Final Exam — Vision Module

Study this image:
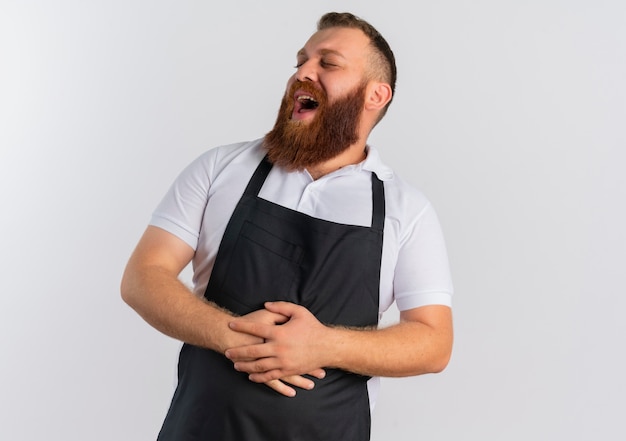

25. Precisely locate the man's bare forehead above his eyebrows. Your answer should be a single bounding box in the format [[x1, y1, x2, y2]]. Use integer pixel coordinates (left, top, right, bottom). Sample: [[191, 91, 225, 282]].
[[298, 27, 370, 61]]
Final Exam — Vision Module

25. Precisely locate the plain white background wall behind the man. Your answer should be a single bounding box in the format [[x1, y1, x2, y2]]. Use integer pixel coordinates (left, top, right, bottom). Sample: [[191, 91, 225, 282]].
[[0, 0, 626, 441]]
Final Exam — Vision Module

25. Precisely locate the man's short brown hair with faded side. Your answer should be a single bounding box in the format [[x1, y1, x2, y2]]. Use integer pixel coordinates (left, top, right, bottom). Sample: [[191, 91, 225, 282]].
[[317, 12, 398, 119]]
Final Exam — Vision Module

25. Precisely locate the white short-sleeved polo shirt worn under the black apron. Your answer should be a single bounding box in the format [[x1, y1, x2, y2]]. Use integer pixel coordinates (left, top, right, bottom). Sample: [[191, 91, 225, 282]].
[[150, 139, 453, 408]]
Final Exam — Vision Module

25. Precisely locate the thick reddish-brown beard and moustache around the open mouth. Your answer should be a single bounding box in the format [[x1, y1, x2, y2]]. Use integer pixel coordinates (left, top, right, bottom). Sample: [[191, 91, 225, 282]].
[[265, 81, 366, 170]]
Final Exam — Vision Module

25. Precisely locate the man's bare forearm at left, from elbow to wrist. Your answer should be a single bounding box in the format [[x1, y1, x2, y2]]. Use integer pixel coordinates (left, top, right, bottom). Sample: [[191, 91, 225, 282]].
[[121, 265, 232, 353]]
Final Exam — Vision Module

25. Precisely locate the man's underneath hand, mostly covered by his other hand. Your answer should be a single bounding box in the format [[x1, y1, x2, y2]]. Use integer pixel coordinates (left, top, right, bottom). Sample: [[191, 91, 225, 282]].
[[222, 309, 326, 397]]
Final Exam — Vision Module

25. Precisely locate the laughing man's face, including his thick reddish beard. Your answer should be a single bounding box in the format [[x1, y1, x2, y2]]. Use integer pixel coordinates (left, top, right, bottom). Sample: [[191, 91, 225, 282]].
[[265, 28, 369, 169]]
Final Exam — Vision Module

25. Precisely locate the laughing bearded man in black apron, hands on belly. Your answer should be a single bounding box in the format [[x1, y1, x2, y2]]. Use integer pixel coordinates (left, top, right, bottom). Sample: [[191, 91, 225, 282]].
[[121, 13, 452, 441]]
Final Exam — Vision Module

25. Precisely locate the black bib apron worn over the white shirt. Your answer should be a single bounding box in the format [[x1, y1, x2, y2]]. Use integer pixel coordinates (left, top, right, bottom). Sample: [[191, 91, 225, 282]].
[[158, 159, 385, 441]]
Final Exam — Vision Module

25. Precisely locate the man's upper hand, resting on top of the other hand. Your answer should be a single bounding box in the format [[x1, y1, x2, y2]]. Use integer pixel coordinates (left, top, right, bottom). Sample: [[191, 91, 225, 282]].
[[225, 302, 329, 383]]
